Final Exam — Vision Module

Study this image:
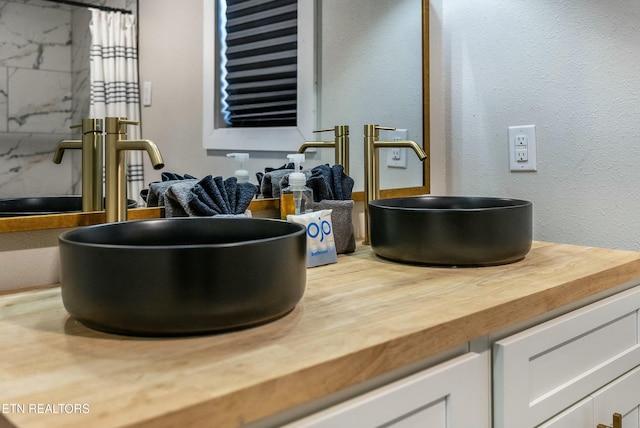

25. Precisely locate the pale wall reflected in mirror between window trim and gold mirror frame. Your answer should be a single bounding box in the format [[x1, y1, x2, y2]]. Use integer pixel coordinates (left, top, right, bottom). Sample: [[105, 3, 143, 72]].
[[319, 0, 423, 190]]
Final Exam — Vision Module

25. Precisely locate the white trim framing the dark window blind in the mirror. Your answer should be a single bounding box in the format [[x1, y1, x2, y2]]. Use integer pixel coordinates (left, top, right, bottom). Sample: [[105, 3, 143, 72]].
[[202, 0, 317, 152]]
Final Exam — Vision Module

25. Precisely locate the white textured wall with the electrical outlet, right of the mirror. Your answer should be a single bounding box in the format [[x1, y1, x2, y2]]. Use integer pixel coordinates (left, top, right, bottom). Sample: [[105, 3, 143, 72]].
[[440, 0, 640, 250]]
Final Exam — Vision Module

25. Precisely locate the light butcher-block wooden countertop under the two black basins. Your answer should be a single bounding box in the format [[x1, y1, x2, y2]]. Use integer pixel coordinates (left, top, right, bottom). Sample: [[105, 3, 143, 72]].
[[0, 242, 640, 428]]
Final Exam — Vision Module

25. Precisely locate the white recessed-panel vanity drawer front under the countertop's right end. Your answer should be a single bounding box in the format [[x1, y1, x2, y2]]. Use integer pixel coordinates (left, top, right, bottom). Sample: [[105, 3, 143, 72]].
[[493, 287, 640, 428]]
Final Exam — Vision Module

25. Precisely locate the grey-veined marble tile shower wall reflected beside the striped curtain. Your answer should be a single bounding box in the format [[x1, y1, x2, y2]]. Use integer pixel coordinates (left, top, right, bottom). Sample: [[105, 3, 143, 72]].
[[0, 0, 136, 198]]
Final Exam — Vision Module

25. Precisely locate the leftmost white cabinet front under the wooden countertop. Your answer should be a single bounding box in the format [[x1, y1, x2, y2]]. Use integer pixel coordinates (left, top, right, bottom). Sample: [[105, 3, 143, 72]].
[[287, 352, 490, 428]]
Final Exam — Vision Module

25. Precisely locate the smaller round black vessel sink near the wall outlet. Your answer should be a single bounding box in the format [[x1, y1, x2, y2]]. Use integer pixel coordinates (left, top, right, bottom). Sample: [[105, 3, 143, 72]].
[[369, 196, 533, 266]]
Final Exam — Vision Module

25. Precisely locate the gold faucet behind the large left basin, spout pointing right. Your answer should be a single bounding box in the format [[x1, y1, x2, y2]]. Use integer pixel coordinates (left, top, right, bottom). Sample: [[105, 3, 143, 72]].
[[105, 117, 164, 222]]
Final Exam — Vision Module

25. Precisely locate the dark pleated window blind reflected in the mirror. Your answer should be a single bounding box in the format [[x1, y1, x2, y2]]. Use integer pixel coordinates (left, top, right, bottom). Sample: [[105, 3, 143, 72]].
[[219, 0, 298, 127]]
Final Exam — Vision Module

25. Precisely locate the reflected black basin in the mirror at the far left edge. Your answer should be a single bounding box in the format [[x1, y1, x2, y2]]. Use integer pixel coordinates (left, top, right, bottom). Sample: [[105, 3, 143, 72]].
[[0, 196, 138, 217]]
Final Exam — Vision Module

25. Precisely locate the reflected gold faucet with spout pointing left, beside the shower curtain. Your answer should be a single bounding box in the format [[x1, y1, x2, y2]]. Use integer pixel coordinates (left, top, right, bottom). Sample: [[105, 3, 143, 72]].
[[53, 118, 103, 212]]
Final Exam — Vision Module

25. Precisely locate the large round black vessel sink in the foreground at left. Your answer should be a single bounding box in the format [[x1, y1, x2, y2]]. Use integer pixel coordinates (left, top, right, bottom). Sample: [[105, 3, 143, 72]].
[[59, 217, 306, 336]]
